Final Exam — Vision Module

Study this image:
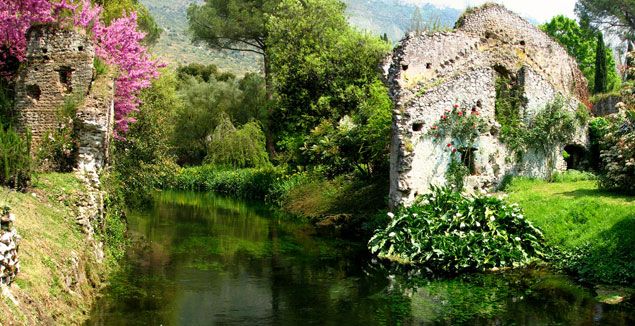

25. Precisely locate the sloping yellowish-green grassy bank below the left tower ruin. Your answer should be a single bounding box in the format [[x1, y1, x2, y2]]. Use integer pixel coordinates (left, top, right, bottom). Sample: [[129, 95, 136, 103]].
[[0, 174, 114, 325]]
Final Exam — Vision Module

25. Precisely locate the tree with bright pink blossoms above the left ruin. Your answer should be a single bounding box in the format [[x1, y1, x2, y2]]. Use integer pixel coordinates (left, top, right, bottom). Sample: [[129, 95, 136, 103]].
[[0, 0, 162, 138]]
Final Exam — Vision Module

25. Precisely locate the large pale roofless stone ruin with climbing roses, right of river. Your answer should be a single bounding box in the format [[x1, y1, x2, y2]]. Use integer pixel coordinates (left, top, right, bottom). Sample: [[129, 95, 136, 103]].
[[384, 4, 588, 207]]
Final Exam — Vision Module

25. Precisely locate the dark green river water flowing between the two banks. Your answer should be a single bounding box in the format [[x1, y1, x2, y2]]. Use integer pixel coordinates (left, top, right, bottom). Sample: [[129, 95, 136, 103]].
[[88, 193, 635, 325]]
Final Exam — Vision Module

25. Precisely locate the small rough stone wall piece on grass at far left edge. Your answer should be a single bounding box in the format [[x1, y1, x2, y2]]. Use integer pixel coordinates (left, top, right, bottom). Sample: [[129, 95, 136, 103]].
[[0, 213, 20, 285]]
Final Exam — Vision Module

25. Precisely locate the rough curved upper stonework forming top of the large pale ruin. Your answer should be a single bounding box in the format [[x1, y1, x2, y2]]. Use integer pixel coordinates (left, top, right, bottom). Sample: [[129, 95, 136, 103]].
[[385, 3, 589, 105]]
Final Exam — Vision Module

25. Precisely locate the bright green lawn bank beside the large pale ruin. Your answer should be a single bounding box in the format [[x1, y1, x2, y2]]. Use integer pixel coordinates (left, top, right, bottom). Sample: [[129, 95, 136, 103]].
[[506, 179, 635, 285]]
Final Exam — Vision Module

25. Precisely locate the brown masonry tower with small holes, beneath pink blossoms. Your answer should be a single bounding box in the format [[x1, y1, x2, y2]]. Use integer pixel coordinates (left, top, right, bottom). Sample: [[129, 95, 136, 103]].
[[16, 25, 95, 149]]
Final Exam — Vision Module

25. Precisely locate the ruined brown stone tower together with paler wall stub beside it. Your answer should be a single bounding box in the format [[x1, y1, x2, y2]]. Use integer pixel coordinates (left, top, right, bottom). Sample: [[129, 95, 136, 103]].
[[16, 24, 114, 170]]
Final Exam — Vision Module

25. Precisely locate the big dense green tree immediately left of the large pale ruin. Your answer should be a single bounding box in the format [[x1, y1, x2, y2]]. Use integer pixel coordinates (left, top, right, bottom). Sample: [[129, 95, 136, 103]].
[[268, 0, 391, 173]]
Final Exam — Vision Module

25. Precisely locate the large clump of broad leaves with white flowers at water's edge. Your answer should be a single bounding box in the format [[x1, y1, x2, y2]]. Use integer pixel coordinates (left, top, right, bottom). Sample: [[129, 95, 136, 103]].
[[368, 188, 544, 272]]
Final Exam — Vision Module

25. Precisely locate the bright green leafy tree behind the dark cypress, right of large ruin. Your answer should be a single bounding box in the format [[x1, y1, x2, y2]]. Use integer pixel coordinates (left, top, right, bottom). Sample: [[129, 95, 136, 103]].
[[540, 15, 621, 92]]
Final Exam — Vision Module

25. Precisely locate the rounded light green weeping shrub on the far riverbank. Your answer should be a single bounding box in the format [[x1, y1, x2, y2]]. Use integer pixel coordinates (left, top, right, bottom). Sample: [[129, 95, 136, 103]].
[[205, 116, 269, 168]]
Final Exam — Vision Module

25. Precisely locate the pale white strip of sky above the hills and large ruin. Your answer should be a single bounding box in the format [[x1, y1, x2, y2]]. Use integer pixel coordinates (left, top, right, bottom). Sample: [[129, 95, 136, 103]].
[[404, 0, 576, 23]]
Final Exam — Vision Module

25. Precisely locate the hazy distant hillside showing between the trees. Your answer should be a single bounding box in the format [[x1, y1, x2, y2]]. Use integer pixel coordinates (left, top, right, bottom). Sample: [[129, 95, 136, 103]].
[[140, 0, 460, 74]]
